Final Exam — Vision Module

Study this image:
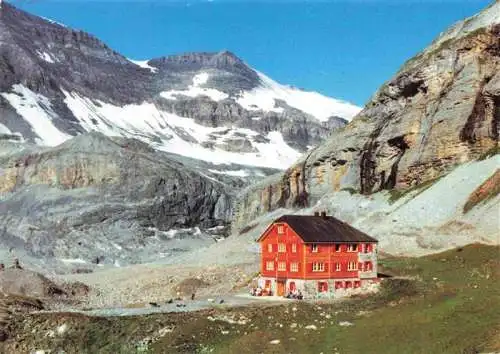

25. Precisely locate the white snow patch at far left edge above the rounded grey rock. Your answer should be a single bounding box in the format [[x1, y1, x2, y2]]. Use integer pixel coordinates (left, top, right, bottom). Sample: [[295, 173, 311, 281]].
[[1, 84, 71, 146]]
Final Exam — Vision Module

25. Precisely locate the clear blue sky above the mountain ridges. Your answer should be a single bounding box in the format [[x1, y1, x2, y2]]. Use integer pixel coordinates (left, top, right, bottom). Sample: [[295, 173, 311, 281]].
[[10, 0, 491, 106]]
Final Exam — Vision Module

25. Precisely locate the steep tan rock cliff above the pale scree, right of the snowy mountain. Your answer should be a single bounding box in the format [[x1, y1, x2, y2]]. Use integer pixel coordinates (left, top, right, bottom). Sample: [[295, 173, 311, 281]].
[[236, 2, 500, 225]]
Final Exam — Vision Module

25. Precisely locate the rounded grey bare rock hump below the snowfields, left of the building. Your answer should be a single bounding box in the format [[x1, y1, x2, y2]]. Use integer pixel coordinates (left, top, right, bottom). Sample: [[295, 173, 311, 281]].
[[0, 133, 235, 267]]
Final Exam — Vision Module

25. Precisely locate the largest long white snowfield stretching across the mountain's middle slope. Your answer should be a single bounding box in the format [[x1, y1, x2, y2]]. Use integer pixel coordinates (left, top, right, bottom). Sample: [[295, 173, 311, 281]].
[[63, 91, 300, 169]]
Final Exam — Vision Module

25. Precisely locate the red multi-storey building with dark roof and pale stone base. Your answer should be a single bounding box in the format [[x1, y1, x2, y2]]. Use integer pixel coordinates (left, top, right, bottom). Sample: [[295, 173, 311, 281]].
[[258, 212, 378, 297]]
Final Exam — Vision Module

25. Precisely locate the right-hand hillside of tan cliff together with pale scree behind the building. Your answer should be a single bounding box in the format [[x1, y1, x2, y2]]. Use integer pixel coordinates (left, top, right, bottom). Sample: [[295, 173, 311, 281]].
[[233, 1, 500, 252]]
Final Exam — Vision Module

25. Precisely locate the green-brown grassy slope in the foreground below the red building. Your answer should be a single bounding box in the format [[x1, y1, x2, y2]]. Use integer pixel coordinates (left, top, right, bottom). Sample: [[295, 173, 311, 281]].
[[0, 245, 500, 354]]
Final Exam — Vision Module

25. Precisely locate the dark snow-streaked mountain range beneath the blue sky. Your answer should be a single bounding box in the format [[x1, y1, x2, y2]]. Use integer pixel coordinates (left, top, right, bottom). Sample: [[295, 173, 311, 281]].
[[0, 2, 360, 168]]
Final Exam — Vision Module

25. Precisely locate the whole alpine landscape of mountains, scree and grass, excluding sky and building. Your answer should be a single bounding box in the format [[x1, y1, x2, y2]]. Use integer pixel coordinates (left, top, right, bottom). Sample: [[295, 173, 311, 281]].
[[0, 0, 500, 354]]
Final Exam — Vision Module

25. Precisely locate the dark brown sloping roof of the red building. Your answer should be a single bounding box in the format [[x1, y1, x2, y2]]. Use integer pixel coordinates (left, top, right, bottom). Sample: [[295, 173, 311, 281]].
[[268, 215, 378, 243]]
